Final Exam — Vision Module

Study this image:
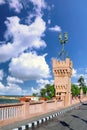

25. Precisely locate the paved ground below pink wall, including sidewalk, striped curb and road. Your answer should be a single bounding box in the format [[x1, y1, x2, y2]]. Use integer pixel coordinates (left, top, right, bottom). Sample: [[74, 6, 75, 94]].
[[0, 102, 87, 130]]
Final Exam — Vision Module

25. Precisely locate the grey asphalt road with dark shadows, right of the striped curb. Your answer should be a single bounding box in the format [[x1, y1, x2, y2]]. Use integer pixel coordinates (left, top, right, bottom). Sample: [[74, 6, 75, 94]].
[[32, 103, 87, 130]]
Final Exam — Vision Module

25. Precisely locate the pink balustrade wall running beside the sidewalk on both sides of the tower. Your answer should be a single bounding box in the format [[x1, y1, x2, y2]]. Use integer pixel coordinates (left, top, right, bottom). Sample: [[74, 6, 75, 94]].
[[0, 96, 87, 126]]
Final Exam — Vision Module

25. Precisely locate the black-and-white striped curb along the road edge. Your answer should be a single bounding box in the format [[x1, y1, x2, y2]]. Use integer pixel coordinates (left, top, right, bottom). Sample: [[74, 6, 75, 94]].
[[12, 103, 81, 130]]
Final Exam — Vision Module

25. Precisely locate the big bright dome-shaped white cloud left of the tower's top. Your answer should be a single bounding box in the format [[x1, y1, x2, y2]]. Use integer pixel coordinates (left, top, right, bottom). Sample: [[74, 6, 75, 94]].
[[9, 52, 50, 80]]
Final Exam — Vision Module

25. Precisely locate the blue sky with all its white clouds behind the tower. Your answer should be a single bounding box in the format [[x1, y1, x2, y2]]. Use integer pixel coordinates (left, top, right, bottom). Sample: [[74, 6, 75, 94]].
[[0, 0, 87, 95]]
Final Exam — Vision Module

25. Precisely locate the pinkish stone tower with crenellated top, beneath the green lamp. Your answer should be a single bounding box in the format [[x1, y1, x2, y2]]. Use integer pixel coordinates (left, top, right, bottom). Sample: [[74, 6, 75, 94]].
[[52, 58, 72, 106]]
